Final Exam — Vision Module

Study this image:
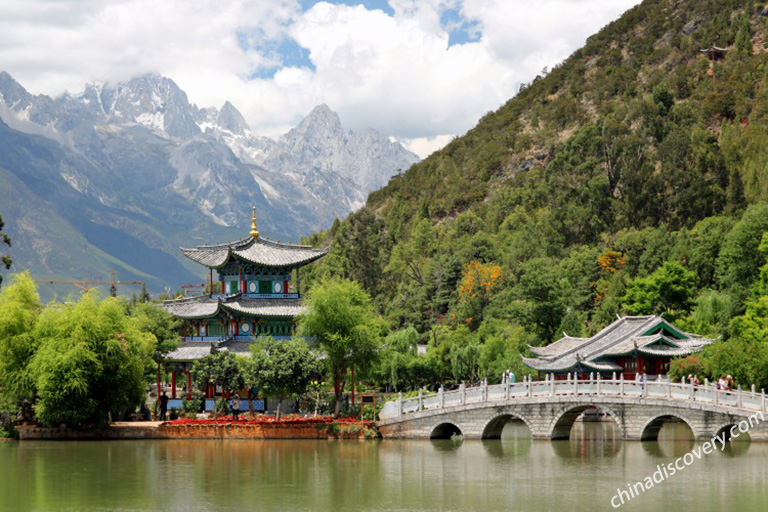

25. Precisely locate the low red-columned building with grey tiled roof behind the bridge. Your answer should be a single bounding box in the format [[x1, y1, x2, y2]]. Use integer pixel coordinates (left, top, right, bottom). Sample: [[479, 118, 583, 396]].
[[523, 315, 712, 380]]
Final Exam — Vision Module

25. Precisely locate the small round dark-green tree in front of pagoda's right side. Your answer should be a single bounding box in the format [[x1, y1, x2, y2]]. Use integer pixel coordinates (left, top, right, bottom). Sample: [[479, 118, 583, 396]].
[[246, 336, 321, 421]]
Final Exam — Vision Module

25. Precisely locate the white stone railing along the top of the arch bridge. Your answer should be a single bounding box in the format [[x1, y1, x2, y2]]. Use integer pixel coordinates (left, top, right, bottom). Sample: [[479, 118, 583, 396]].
[[390, 374, 766, 419]]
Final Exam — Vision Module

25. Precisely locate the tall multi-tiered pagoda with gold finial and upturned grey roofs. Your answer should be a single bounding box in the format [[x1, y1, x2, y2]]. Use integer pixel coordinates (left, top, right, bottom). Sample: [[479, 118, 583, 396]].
[[158, 207, 327, 409]]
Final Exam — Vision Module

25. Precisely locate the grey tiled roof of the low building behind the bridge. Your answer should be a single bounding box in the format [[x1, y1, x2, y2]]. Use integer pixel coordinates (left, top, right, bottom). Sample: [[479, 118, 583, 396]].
[[523, 315, 712, 371]]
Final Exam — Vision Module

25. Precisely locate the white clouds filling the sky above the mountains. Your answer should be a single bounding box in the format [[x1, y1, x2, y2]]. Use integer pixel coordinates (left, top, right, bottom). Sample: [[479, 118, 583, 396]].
[[0, 0, 638, 155]]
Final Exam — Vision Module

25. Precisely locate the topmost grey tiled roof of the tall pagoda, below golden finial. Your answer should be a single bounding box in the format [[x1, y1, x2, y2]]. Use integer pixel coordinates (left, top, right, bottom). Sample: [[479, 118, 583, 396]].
[[181, 236, 328, 268]]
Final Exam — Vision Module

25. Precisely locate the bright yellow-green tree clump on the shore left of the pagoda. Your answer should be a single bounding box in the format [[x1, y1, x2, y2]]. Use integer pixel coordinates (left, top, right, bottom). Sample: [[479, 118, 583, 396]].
[[0, 272, 176, 428]]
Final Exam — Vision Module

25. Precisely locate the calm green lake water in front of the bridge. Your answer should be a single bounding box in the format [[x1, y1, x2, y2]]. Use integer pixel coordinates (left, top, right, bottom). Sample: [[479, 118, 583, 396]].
[[0, 424, 768, 512]]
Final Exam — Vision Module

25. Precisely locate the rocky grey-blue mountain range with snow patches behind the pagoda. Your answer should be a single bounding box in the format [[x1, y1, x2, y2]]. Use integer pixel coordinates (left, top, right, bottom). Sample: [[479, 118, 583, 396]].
[[0, 72, 418, 296]]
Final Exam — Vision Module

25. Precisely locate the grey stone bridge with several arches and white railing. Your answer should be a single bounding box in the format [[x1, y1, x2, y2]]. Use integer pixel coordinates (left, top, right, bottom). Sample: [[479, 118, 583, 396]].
[[378, 377, 768, 441]]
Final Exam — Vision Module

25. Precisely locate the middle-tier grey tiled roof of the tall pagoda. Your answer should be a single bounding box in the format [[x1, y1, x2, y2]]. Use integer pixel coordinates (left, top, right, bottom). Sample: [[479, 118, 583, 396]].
[[162, 293, 305, 320]]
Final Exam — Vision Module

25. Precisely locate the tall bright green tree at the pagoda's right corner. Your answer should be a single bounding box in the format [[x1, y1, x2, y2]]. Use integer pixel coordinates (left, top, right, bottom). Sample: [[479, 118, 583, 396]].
[[298, 278, 384, 416]]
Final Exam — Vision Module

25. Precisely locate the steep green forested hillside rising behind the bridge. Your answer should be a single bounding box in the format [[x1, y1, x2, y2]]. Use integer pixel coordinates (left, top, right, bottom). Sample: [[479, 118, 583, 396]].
[[300, 0, 768, 388]]
